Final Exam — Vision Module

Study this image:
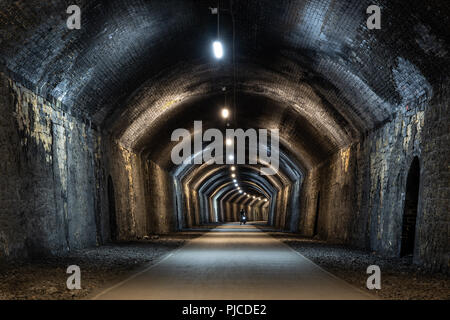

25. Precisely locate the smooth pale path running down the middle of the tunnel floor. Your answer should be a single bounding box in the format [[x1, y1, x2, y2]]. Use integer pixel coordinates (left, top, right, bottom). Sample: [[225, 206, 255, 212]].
[[94, 224, 373, 300]]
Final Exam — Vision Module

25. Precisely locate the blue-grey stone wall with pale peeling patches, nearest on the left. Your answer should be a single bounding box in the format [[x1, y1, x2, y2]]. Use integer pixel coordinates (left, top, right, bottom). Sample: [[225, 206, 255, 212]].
[[0, 74, 100, 258]]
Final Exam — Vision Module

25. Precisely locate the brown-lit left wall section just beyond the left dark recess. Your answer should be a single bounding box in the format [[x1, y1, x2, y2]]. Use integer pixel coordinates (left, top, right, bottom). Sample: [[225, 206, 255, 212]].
[[87, 137, 177, 241]]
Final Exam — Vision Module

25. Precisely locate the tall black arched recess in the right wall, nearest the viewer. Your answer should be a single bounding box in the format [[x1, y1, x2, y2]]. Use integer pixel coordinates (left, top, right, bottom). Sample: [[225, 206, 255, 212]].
[[400, 157, 420, 257]]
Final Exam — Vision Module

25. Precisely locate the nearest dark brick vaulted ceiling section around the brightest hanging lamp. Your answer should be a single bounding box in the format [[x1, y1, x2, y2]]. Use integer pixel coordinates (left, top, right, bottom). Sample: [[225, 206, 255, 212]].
[[0, 0, 450, 154]]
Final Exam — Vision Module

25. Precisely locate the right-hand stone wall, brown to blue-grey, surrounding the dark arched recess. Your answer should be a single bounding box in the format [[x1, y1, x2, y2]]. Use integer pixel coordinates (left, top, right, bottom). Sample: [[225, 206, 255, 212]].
[[299, 79, 450, 272]]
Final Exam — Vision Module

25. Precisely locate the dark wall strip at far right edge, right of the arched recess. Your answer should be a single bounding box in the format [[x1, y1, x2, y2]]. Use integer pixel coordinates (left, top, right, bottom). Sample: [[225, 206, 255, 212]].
[[416, 79, 450, 273]]
